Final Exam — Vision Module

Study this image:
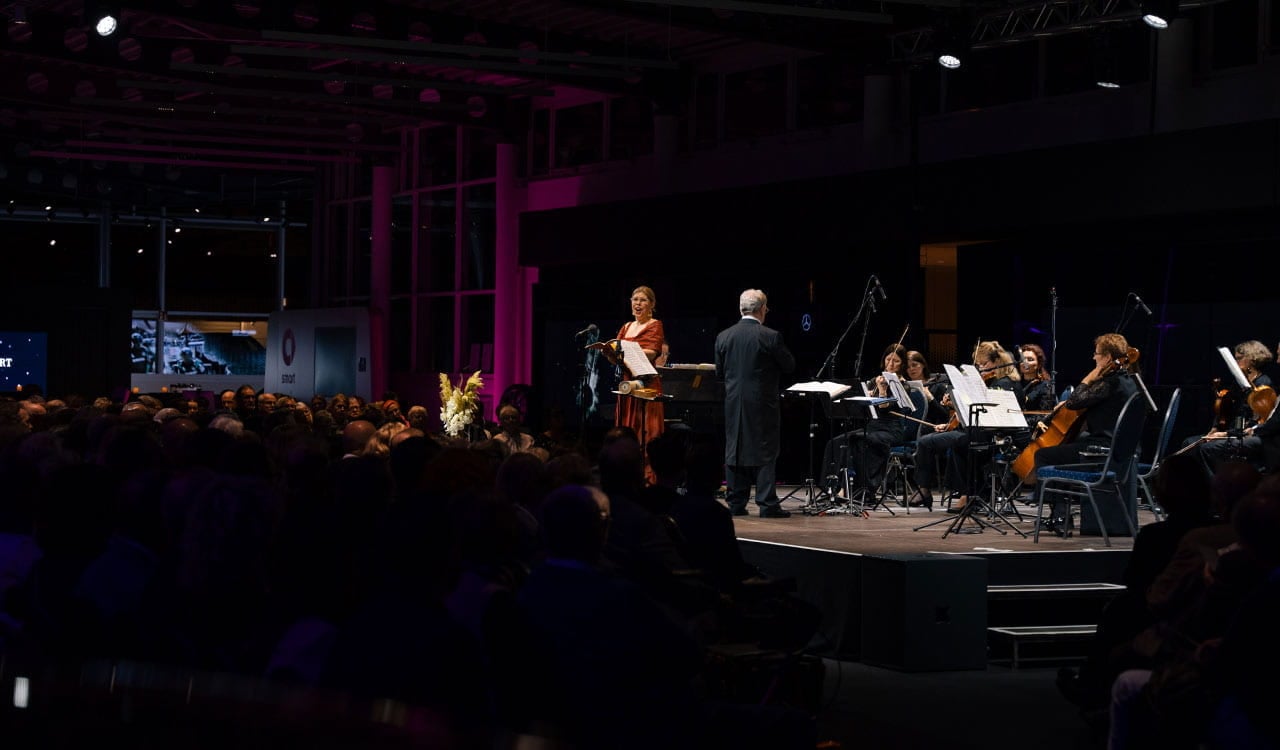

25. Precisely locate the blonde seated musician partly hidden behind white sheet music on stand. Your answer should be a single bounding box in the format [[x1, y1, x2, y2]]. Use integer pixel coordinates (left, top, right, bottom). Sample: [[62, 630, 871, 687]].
[[908, 340, 1019, 513]]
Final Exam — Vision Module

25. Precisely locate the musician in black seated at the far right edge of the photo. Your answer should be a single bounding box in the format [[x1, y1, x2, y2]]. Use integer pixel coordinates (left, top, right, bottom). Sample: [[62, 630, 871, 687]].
[[1199, 340, 1280, 474]]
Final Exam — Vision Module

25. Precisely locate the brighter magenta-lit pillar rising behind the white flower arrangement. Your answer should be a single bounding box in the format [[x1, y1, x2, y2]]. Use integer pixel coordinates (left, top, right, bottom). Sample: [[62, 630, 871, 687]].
[[488, 143, 538, 403]]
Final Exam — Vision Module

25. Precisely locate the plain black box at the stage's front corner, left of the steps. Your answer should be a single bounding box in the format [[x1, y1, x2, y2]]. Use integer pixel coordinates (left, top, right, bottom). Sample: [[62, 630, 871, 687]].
[[861, 554, 987, 672]]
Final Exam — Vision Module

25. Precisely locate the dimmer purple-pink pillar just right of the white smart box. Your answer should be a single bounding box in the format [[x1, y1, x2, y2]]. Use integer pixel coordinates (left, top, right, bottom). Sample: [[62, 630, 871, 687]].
[[367, 161, 396, 401]]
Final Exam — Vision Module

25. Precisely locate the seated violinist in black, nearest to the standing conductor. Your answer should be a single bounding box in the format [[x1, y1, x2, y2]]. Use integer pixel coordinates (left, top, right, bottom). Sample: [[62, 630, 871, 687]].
[[823, 343, 925, 491]]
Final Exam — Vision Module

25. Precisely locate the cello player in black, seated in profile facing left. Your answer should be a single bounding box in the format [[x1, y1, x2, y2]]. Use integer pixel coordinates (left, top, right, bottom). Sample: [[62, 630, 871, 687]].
[[1028, 333, 1138, 536]]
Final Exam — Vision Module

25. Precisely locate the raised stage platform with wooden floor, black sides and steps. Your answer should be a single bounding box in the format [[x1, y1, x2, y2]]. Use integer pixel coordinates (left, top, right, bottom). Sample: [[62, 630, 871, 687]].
[[733, 486, 1155, 671]]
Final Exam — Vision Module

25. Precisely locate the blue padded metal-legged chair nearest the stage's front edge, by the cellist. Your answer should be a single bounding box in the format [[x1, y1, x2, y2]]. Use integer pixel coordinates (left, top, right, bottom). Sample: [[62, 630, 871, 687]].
[[1034, 393, 1147, 547]]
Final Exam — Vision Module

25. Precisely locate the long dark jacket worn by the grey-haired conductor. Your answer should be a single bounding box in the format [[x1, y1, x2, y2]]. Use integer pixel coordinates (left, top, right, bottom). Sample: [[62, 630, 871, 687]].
[[716, 317, 796, 466]]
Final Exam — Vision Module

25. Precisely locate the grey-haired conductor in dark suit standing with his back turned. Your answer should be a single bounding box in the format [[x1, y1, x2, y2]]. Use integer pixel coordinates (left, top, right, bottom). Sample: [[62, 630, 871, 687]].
[[716, 289, 796, 518]]
